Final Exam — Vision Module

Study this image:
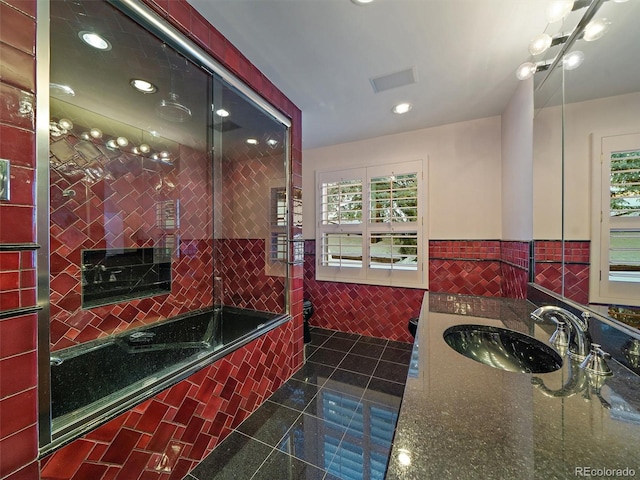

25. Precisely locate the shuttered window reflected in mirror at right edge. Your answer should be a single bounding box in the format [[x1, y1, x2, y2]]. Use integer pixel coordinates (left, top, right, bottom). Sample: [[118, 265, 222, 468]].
[[590, 134, 640, 305]]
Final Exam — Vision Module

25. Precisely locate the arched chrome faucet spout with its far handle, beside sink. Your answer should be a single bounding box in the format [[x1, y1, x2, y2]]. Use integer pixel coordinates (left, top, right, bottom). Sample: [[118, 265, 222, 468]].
[[531, 305, 591, 360]]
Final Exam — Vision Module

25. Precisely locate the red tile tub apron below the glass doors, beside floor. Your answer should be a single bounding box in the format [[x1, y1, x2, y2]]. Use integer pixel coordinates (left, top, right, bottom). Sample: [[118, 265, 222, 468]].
[[40, 322, 302, 480]]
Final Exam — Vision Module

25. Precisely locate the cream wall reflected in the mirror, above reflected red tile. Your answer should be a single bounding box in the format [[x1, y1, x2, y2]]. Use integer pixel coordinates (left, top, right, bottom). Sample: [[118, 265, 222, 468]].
[[533, 92, 640, 240]]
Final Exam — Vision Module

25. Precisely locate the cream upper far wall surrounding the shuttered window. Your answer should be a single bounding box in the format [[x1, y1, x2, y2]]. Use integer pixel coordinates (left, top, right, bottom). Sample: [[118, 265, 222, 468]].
[[302, 117, 501, 240]]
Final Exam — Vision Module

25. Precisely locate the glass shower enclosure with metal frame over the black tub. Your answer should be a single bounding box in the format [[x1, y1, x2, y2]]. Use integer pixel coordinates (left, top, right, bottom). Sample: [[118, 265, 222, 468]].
[[38, 0, 290, 449]]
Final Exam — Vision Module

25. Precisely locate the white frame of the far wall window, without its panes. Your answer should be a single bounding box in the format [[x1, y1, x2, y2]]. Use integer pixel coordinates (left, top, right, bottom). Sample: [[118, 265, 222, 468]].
[[315, 160, 428, 288]]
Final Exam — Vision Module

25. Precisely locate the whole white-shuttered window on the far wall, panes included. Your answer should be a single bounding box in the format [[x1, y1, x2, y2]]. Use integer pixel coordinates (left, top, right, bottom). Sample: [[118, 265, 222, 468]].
[[316, 161, 426, 287]]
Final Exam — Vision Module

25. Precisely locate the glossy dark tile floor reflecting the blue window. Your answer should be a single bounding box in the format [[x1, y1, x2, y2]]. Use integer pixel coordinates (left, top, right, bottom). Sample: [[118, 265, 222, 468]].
[[185, 327, 412, 480]]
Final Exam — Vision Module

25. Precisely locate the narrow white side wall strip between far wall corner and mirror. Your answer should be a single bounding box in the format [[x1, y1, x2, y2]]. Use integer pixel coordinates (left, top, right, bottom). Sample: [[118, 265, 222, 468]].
[[500, 78, 533, 241]]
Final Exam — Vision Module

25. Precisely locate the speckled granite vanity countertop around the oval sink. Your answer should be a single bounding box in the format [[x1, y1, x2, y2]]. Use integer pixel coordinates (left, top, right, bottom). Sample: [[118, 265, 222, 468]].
[[386, 293, 640, 480]]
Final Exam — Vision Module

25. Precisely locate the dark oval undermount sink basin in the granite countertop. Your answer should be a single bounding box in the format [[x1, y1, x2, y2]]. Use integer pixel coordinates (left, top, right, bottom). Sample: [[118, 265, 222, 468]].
[[443, 325, 562, 373]]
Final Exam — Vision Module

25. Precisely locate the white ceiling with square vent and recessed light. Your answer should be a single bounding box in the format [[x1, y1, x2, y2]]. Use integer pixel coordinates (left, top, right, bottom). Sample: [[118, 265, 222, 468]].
[[189, 0, 547, 149]]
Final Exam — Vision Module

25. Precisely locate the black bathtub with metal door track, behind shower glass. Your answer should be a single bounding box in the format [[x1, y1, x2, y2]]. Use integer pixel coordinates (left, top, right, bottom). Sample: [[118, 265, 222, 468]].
[[51, 306, 290, 443]]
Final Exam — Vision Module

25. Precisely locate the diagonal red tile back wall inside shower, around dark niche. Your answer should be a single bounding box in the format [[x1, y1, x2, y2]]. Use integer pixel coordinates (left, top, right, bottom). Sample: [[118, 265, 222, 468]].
[[50, 141, 213, 351]]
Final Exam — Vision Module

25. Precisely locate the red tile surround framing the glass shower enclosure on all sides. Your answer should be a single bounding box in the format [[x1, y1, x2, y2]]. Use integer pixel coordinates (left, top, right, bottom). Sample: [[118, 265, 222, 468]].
[[0, 0, 303, 480]]
